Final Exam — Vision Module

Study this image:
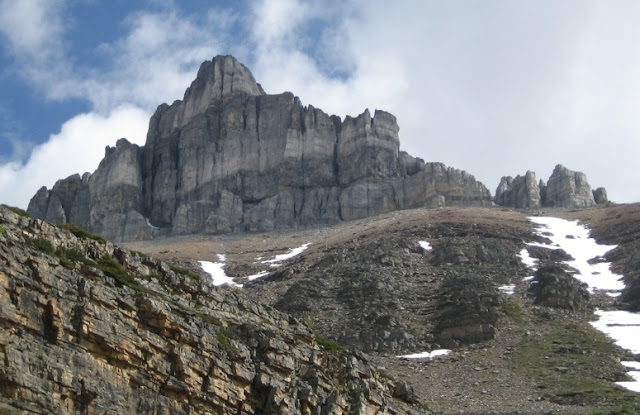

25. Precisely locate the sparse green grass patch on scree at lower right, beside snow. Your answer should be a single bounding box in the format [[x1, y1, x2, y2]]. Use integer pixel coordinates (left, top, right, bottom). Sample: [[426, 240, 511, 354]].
[[511, 324, 640, 407]]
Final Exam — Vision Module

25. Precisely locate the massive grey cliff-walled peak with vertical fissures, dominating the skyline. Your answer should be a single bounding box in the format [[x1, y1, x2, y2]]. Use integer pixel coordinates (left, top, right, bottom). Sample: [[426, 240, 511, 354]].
[[28, 56, 492, 241]]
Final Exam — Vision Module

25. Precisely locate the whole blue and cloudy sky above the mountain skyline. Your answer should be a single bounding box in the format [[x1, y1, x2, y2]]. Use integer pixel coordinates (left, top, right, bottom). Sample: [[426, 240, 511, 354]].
[[0, 0, 640, 208]]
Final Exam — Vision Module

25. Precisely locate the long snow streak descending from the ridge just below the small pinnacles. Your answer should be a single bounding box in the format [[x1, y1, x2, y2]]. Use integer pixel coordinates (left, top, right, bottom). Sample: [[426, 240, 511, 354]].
[[527, 217, 624, 292]]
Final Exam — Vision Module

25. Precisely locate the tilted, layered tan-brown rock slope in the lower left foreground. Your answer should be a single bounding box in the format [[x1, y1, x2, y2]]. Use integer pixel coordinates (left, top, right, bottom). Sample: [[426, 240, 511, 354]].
[[0, 208, 423, 415]]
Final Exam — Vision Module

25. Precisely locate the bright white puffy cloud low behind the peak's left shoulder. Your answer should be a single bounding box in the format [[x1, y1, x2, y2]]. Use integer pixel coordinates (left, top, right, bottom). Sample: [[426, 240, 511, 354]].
[[0, 105, 149, 208]]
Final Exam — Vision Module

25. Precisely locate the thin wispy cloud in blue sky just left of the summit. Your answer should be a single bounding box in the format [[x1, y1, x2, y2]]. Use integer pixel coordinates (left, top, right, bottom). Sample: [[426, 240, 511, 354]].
[[80, 11, 228, 111]]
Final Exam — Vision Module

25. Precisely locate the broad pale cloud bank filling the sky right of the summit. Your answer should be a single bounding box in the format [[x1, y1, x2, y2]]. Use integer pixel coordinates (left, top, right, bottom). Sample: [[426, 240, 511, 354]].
[[252, 0, 640, 202]]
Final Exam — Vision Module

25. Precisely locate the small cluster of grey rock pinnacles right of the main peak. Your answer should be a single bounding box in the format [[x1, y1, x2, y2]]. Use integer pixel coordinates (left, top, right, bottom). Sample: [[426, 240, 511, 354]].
[[494, 164, 608, 209]]
